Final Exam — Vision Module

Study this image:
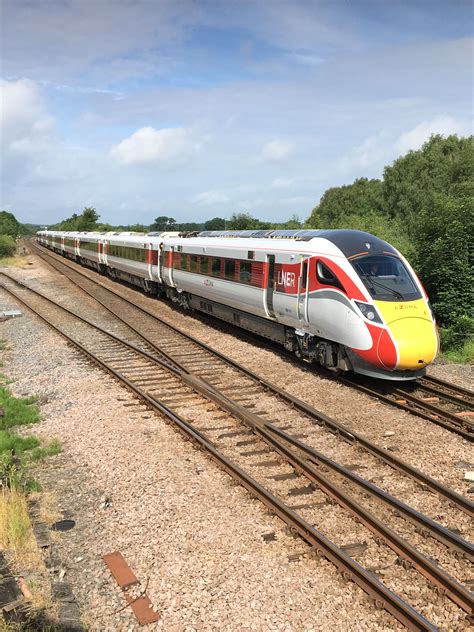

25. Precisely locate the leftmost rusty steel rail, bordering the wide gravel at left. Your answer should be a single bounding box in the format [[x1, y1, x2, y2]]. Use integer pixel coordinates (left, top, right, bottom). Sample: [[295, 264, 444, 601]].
[[1, 273, 436, 630]]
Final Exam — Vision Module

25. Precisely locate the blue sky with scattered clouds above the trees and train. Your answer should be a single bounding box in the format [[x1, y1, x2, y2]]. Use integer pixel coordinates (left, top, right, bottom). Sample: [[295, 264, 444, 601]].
[[0, 0, 474, 225]]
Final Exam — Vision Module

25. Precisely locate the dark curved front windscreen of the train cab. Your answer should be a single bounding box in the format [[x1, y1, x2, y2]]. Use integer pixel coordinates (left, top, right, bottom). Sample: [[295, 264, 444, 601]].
[[351, 255, 421, 301]]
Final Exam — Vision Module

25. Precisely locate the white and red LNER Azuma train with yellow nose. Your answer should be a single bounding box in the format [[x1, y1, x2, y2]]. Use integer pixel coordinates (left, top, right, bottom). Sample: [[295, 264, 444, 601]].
[[36, 229, 439, 380]]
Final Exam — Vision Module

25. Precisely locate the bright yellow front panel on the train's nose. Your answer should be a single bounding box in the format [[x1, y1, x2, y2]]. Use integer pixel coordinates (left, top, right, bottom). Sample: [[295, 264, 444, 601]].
[[389, 318, 438, 369]]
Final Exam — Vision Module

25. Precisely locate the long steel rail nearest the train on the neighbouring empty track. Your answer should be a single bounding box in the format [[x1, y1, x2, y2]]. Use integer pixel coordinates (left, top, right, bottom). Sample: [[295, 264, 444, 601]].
[[26, 244, 474, 516]]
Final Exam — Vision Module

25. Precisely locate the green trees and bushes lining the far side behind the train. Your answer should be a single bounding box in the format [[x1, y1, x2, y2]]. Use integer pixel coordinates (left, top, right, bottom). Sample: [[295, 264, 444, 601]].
[[0, 135, 474, 356]]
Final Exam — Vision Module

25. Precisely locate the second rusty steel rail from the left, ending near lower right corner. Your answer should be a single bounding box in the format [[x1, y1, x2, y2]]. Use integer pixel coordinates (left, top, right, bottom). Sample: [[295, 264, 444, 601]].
[[0, 273, 473, 613]]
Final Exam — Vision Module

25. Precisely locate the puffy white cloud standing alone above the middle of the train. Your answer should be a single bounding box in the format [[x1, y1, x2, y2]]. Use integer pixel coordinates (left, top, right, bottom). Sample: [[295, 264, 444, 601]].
[[111, 127, 200, 166]]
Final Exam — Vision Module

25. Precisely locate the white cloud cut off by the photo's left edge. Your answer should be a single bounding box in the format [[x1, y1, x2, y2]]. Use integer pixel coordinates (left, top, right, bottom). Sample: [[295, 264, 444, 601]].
[[0, 79, 54, 155]]
